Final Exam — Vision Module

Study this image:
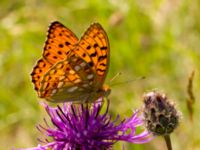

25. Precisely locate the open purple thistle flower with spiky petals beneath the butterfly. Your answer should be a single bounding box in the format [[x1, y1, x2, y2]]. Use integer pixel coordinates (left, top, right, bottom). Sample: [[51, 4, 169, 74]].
[[20, 100, 152, 150]]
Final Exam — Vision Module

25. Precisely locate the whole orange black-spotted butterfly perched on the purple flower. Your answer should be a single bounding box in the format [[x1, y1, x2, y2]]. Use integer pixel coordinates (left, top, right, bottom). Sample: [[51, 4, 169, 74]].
[[31, 21, 111, 102]]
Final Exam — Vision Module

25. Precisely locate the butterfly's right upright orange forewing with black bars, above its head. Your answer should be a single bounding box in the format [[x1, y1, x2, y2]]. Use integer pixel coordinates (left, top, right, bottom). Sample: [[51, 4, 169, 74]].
[[73, 23, 110, 89]]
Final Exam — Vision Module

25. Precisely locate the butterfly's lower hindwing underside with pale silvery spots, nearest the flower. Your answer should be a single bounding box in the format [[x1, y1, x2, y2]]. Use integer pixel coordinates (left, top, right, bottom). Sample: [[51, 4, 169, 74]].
[[39, 56, 94, 102]]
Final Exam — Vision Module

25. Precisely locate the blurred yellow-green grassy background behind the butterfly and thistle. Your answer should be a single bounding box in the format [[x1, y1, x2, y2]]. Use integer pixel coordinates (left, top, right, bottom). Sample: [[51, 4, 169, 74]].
[[0, 0, 200, 150]]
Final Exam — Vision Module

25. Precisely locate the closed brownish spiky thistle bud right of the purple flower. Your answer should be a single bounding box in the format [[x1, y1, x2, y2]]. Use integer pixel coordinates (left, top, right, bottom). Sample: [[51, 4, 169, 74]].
[[143, 91, 180, 136]]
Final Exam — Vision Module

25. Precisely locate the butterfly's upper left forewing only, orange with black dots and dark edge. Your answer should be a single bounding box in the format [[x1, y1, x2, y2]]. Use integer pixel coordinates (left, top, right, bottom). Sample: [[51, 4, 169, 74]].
[[43, 21, 78, 64]]
